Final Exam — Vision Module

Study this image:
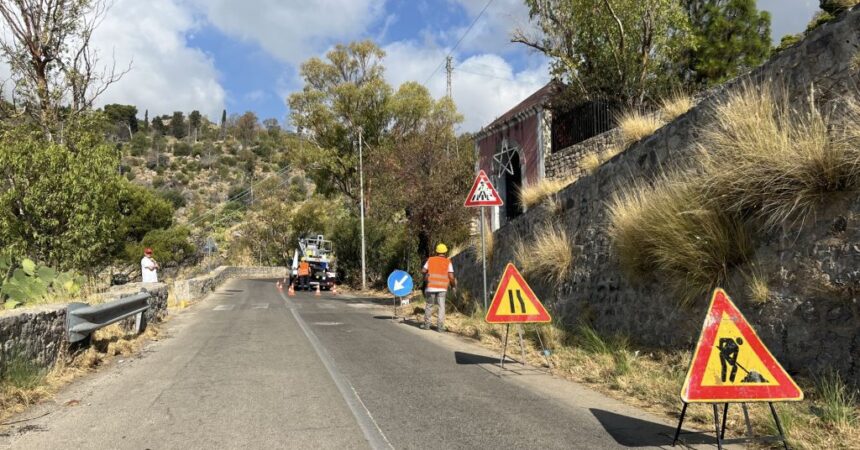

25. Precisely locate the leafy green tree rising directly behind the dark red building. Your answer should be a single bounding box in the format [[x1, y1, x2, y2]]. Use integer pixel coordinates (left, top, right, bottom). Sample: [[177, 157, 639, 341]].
[[512, 0, 691, 107]]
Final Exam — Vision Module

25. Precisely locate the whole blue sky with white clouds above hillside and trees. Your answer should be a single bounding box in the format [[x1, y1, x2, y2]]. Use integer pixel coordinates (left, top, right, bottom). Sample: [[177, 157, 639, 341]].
[[85, 0, 818, 131]]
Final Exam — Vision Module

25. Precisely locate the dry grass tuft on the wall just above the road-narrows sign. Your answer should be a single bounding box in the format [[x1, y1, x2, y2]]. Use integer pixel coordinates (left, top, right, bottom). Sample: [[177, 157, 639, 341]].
[[514, 224, 573, 285]]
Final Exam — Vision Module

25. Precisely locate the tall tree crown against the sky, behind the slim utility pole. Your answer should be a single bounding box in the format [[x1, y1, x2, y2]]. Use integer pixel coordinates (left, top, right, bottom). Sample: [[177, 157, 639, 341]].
[[288, 41, 391, 201]]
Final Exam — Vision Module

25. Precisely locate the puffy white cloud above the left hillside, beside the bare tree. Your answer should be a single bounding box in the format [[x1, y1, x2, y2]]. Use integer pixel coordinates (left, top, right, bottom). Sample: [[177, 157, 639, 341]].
[[93, 0, 225, 118]]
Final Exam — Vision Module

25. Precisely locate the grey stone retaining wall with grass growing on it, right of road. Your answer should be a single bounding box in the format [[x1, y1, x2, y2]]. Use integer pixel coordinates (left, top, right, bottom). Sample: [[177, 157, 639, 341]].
[[454, 8, 860, 385]]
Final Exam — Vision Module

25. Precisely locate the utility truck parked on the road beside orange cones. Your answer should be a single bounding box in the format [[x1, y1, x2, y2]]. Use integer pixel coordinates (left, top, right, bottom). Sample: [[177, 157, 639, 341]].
[[290, 234, 337, 291]]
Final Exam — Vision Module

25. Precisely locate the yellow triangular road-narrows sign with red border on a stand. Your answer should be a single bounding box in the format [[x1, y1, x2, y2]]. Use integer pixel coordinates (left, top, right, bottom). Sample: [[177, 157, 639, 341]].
[[486, 263, 552, 323]]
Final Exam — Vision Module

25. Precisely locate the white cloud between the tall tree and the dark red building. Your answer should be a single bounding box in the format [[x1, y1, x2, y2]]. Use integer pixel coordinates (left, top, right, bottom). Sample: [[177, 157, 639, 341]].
[[385, 42, 549, 131]]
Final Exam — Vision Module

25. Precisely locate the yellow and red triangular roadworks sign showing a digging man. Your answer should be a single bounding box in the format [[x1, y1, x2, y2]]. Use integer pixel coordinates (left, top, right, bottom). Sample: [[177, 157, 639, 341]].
[[681, 289, 803, 403]]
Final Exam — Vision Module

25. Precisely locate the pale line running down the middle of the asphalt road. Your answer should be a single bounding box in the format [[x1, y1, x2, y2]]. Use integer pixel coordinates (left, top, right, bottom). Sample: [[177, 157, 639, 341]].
[[279, 292, 394, 449]]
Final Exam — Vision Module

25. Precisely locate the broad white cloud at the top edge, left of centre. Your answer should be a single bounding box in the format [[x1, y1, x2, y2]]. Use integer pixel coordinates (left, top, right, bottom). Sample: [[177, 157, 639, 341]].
[[192, 0, 385, 64]]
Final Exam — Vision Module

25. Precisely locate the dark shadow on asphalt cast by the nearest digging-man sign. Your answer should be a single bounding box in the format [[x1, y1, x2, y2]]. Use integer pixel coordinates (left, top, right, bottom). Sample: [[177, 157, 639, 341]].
[[590, 408, 715, 447]]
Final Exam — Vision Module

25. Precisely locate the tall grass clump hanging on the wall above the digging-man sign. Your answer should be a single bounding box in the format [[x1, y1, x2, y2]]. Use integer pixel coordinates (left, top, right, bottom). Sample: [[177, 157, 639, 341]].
[[609, 173, 752, 304]]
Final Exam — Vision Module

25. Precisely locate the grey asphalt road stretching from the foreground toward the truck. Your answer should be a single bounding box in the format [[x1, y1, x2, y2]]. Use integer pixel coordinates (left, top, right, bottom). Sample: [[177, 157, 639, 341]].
[[0, 280, 702, 449]]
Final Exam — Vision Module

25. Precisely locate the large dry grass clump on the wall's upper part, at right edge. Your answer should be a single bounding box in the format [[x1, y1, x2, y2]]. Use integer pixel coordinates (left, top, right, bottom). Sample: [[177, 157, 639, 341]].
[[701, 85, 860, 229]]
